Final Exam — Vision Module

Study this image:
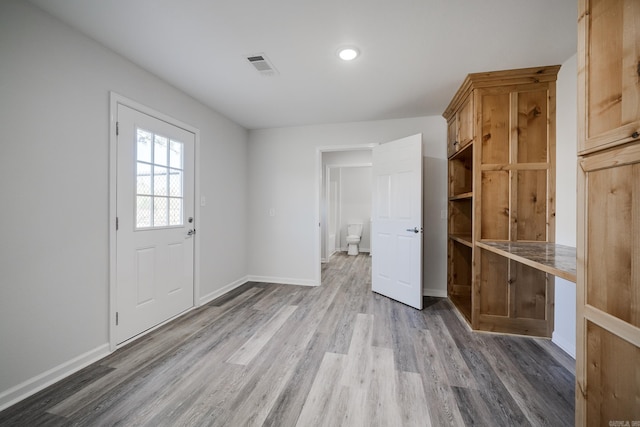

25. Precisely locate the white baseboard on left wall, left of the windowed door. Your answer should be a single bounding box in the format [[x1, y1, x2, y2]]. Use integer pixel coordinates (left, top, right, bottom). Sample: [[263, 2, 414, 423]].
[[0, 343, 111, 411]]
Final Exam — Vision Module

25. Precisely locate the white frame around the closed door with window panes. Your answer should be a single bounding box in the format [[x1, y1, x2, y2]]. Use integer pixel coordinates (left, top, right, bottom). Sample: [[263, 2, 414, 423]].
[[108, 91, 200, 351]]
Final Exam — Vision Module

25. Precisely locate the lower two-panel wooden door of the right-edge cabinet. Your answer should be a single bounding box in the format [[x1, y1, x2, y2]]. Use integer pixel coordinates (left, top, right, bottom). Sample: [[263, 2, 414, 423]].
[[576, 143, 640, 426]]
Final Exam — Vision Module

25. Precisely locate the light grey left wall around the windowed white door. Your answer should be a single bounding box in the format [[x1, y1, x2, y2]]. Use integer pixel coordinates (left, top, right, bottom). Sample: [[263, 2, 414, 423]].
[[0, 0, 248, 408]]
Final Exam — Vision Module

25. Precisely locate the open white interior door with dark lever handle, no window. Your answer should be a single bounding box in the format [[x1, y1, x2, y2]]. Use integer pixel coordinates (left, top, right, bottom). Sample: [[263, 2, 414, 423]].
[[371, 134, 422, 310]]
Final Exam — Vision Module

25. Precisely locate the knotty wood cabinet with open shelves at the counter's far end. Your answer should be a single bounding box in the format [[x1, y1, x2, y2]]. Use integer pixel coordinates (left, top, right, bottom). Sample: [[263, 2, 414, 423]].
[[443, 66, 560, 337]]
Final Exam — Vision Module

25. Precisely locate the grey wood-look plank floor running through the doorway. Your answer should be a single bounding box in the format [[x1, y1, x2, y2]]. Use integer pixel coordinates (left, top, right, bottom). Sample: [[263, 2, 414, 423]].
[[0, 254, 574, 427]]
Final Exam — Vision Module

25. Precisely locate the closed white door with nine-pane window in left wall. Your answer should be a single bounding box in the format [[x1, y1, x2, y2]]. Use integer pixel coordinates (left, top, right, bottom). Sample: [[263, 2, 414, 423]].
[[116, 104, 195, 344]]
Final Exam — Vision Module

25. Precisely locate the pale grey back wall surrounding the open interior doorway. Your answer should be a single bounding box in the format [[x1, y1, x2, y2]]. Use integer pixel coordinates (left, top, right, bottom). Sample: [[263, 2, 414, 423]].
[[249, 116, 447, 296]]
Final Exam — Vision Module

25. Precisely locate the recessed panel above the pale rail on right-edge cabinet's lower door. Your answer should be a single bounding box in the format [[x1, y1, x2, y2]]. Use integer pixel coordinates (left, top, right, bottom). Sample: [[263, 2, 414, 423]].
[[586, 159, 640, 327]]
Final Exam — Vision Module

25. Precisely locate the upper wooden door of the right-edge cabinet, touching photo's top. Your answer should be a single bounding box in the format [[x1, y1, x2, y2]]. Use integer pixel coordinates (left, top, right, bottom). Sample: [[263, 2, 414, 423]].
[[578, 0, 640, 154]]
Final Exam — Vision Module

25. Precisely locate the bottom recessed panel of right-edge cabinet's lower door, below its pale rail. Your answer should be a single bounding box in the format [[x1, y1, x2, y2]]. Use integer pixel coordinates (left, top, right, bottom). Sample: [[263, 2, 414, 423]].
[[580, 321, 640, 426]]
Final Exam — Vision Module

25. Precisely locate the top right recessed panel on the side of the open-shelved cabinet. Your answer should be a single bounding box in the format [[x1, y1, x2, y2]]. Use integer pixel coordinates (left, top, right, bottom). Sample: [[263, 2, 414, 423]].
[[517, 89, 549, 163]]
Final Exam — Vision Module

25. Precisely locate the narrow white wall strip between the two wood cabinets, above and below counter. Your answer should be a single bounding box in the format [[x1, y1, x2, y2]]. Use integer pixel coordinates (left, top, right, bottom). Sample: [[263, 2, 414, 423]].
[[553, 55, 578, 358]]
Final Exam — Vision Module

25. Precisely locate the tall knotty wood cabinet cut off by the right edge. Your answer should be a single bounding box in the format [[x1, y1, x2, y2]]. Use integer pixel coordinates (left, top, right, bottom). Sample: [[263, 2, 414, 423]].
[[576, 0, 640, 426]]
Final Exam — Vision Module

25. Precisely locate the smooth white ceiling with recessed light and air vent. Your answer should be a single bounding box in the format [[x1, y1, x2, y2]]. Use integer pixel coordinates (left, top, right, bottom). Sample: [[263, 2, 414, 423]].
[[30, 0, 577, 129]]
